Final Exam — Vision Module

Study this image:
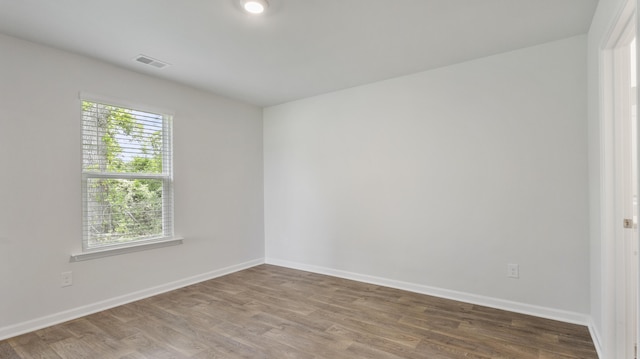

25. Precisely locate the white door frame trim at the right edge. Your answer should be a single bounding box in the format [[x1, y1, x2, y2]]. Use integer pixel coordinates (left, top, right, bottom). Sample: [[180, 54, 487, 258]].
[[599, 0, 640, 358]]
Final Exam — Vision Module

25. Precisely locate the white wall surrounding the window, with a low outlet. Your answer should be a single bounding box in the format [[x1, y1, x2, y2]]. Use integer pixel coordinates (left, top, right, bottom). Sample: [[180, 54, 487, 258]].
[[0, 35, 264, 338]]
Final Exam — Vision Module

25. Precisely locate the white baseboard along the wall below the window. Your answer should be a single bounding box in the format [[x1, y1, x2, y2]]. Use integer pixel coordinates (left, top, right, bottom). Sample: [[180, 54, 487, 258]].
[[0, 258, 264, 340]]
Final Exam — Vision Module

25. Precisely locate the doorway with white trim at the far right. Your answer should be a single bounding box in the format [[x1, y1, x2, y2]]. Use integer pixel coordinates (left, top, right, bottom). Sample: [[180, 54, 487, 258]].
[[603, 1, 640, 358]]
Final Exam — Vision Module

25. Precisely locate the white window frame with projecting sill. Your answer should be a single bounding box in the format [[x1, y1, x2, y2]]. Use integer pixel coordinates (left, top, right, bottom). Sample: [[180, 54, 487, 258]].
[[70, 92, 183, 262]]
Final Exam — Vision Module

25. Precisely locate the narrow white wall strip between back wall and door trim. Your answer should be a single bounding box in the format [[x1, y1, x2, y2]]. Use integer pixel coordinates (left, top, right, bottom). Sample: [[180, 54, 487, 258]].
[[588, 0, 626, 358]]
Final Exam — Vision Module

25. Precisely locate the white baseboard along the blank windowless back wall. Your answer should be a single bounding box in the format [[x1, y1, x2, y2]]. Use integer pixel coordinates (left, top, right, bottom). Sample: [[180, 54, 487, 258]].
[[265, 258, 590, 326]]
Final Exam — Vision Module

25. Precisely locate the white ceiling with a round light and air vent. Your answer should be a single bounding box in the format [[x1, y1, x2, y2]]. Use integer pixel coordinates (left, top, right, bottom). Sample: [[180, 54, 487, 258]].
[[0, 0, 597, 106]]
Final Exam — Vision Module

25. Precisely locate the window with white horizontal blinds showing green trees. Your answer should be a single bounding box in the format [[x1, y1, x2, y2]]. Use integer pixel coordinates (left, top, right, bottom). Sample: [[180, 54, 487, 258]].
[[80, 99, 173, 260]]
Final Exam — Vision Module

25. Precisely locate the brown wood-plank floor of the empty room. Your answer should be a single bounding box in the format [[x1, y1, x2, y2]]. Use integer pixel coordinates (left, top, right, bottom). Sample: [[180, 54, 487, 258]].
[[0, 265, 597, 359]]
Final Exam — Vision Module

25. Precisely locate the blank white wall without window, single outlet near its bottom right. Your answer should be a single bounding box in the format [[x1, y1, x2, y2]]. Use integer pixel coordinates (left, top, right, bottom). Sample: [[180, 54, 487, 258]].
[[264, 36, 590, 321]]
